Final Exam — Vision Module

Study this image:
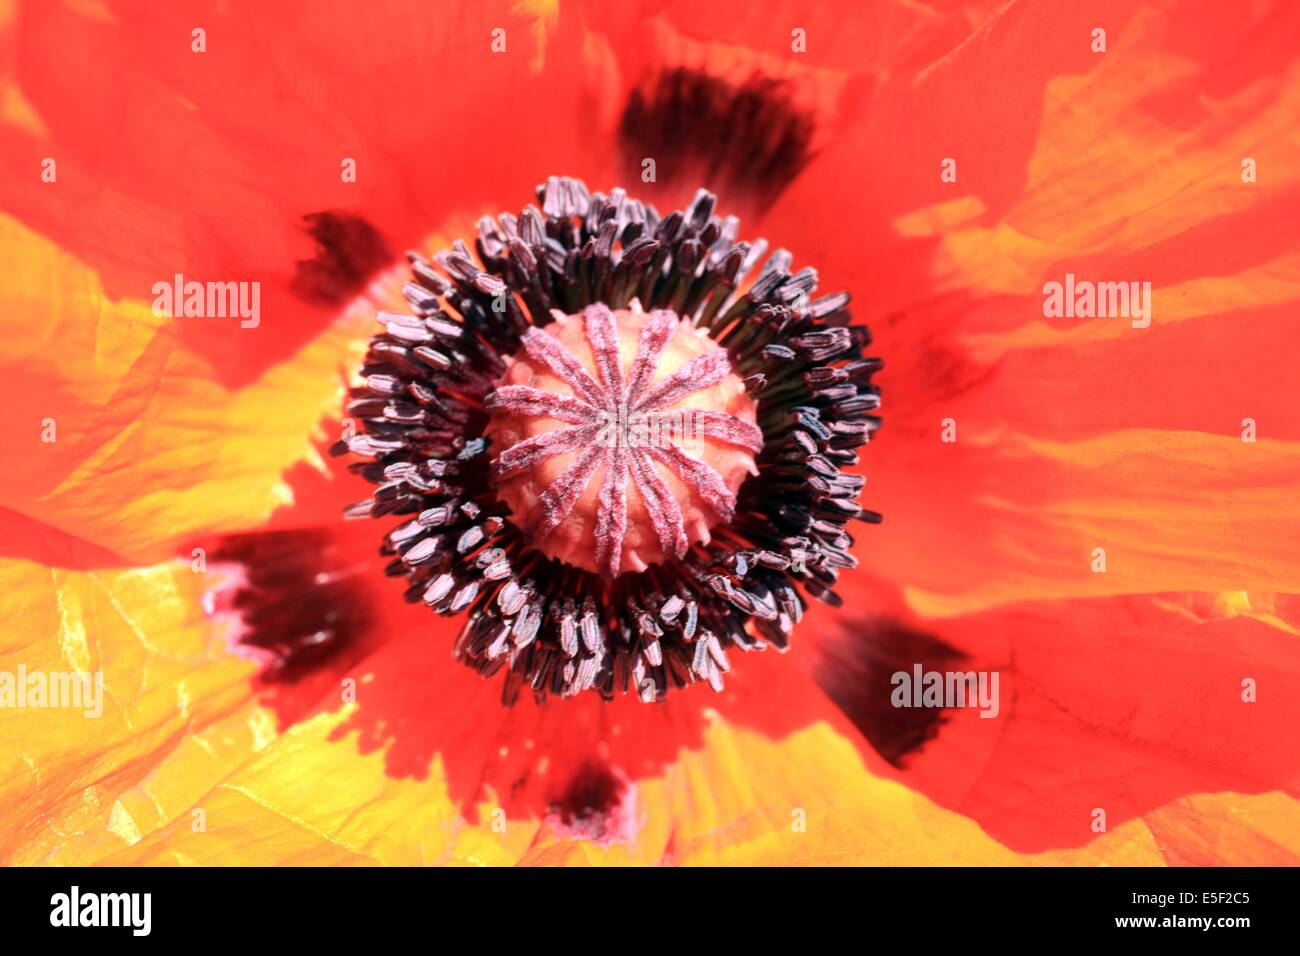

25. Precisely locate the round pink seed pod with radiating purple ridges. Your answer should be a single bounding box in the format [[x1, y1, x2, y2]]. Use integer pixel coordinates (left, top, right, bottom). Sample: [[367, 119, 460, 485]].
[[486, 299, 763, 576]]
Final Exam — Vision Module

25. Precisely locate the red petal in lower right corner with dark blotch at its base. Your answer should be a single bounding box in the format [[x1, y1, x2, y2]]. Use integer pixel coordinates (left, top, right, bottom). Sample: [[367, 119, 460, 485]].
[[816, 593, 1300, 865]]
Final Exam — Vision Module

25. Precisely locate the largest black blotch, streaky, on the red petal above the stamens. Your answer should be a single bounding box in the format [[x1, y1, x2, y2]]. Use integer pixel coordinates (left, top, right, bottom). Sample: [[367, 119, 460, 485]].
[[619, 68, 815, 211]]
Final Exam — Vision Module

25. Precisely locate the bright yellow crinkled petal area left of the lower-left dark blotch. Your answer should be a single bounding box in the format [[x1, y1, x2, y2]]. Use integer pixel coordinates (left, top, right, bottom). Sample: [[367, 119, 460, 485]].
[[0, 561, 274, 865]]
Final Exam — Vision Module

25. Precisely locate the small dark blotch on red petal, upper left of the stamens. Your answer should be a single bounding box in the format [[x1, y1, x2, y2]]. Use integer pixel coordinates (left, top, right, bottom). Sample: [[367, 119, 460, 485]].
[[293, 212, 393, 307]]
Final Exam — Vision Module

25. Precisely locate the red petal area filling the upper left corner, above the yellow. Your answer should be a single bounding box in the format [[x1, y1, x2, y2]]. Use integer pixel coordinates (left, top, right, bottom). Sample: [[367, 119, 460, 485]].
[[0, 0, 590, 386]]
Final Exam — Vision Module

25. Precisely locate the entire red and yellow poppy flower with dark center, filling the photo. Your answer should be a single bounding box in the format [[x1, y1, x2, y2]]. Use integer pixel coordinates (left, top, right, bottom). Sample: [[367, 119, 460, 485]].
[[0, 0, 1300, 865]]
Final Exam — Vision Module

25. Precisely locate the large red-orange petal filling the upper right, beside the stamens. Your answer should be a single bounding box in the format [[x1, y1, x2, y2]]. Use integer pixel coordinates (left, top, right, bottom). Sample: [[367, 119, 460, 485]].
[[772, 4, 1300, 614]]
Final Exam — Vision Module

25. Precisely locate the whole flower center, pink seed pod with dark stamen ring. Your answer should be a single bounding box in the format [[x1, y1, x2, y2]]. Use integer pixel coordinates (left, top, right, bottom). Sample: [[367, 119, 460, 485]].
[[333, 177, 880, 704]]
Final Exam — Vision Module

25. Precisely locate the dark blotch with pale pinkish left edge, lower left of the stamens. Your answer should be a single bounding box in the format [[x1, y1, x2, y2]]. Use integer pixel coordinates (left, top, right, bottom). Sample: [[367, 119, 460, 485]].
[[209, 528, 371, 683]]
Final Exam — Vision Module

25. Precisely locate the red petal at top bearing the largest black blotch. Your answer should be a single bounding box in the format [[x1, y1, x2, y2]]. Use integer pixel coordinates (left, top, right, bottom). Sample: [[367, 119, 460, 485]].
[[564, 0, 1003, 218]]
